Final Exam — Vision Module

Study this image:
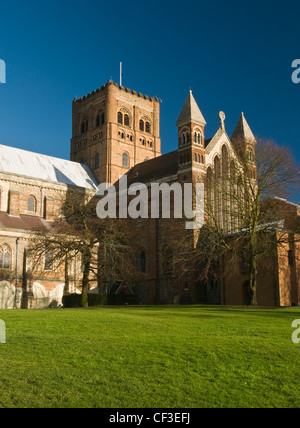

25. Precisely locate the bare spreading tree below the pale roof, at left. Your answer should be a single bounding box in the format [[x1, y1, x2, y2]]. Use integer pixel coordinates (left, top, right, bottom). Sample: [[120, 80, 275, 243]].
[[31, 192, 139, 307]]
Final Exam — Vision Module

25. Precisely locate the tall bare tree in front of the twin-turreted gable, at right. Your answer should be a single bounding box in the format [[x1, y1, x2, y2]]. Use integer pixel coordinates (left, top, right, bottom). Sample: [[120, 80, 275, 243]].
[[204, 140, 299, 305]]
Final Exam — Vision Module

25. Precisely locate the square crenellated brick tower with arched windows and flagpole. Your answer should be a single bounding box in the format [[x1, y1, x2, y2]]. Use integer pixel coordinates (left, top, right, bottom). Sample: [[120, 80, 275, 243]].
[[71, 80, 161, 184]]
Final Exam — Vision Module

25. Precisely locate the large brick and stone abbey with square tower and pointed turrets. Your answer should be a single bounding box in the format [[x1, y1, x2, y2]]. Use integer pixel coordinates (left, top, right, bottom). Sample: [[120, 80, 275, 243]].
[[0, 81, 300, 308]]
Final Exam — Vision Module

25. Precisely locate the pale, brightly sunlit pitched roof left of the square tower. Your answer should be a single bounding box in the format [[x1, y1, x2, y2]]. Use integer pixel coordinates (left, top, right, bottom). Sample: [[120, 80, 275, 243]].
[[0, 145, 98, 189]]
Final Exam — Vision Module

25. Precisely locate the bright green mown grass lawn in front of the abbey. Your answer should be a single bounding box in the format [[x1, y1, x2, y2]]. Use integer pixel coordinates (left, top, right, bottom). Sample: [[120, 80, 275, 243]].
[[0, 306, 300, 408]]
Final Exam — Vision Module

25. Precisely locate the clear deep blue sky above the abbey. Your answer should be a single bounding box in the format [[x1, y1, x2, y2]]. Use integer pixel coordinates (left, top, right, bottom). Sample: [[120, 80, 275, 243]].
[[0, 0, 300, 197]]
